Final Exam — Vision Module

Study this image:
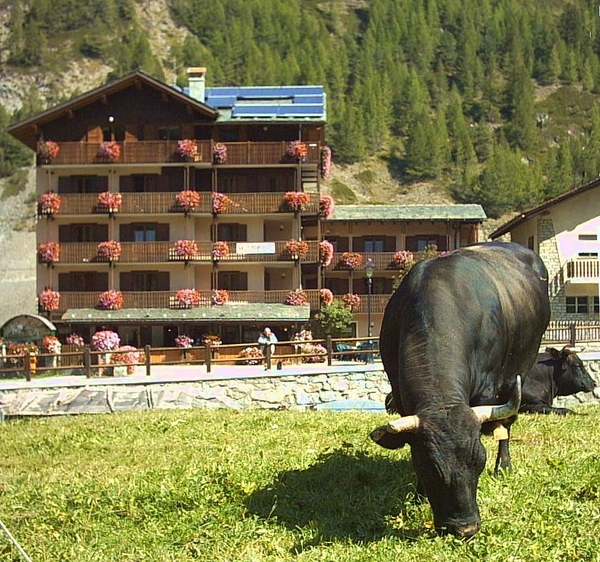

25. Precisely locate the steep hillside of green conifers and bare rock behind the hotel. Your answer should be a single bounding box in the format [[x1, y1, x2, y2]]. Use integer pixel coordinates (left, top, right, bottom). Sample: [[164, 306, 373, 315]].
[[0, 0, 600, 217]]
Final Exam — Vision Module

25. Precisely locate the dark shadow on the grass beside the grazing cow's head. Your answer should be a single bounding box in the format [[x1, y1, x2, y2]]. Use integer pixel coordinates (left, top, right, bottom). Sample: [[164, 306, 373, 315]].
[[246, 446, 430, 552]]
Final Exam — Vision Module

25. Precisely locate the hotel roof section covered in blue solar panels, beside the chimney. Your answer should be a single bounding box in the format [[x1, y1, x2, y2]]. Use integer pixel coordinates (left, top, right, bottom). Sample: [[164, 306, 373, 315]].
[[205, 86, 327, 122]]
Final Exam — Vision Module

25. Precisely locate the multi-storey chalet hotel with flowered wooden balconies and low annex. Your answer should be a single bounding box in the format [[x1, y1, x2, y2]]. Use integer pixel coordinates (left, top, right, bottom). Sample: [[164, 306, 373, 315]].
[[8, 68, 485, 347]]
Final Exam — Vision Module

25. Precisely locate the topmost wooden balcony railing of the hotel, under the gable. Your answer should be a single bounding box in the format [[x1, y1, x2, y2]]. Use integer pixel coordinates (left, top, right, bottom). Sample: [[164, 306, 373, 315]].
[[40, 140, 321, 167]]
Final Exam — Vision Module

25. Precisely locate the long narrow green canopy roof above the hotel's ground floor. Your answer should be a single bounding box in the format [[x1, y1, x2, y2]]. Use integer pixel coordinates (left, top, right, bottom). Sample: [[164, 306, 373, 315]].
[[61, 303, 310, 324]]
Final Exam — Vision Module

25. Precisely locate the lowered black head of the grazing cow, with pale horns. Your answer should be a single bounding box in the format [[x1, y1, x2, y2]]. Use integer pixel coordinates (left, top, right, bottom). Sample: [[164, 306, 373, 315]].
[[371, 378, 521, 538]]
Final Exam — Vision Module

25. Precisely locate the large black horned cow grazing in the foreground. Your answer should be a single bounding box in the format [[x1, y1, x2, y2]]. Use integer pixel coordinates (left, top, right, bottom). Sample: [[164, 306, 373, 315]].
[[371, 238, 550, 538]]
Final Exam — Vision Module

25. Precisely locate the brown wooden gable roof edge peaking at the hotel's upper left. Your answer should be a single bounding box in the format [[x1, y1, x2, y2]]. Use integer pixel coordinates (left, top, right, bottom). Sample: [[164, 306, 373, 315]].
[[6, 70, 219, 148]]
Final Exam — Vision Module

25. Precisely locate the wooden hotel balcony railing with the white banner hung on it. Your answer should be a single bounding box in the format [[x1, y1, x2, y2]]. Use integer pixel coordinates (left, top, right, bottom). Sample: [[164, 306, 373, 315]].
[[54, 240, 319, 267]]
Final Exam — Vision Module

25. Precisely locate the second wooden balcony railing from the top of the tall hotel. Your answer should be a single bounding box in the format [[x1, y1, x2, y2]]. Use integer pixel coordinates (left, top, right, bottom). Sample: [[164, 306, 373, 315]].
[[45, 186, 319, 217]]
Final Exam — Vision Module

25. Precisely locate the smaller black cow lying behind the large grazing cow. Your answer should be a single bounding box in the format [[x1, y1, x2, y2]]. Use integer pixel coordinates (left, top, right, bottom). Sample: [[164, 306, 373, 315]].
[[519, 346, 596, 416]]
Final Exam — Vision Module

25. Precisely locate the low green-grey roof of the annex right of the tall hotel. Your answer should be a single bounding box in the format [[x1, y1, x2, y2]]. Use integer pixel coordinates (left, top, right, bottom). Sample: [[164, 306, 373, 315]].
[[327, 205, 487, 221]]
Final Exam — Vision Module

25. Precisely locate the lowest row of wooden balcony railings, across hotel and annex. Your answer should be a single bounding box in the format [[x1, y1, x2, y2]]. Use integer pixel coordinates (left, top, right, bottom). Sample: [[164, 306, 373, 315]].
[[43, 289, 391, 319]]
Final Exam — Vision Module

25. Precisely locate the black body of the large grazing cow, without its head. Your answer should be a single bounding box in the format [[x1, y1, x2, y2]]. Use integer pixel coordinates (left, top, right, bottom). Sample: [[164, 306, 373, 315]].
[[380, 238, 550, 414]]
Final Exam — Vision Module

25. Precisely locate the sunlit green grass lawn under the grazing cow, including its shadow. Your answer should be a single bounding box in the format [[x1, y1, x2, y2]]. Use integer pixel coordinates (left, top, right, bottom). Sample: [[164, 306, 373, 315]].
[[0, 406, 600, 562]]
